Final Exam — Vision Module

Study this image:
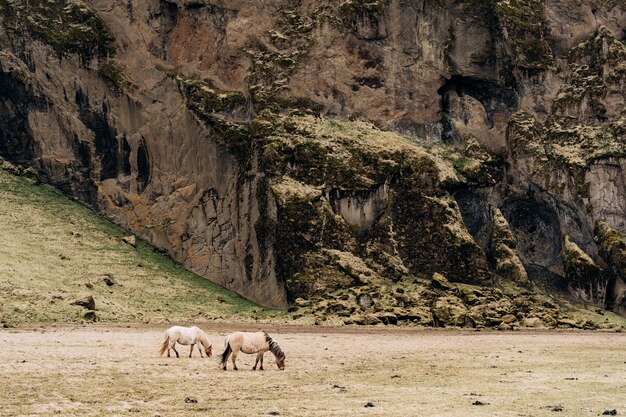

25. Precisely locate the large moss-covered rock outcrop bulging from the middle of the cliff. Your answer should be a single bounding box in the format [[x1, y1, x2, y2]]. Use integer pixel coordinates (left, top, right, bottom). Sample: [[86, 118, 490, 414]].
[[256, 113, 491, 298]]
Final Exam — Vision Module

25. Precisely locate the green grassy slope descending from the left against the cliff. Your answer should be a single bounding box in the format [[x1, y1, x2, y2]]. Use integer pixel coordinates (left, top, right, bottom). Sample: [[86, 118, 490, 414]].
[[0, 169, 279, 326]]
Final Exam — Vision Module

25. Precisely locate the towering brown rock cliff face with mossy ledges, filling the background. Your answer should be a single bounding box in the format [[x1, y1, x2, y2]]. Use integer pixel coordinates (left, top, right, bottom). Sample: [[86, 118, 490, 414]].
[[0, 0, 626, 313]]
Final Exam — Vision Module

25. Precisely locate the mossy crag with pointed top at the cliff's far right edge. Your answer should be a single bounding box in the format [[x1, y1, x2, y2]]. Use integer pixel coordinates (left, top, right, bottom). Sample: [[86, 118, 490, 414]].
[[507, 27, 626, 203]]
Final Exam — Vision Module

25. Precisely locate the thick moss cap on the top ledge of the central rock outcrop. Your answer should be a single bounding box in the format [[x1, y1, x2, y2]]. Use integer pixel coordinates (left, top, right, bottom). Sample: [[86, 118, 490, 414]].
[[262, 116, 463, 192]]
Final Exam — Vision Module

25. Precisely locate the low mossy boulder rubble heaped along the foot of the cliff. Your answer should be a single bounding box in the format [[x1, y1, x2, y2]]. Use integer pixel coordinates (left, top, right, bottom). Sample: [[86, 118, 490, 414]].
[[290, 278, 624, 330]]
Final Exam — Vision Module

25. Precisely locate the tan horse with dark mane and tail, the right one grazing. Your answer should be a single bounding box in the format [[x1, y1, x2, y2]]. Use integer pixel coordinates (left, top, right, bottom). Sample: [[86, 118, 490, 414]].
[[220, 332, 285, 371]]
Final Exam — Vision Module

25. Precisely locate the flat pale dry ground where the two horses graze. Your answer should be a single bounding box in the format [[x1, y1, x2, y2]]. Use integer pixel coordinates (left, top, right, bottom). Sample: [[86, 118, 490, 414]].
[[0, 324, 626, 417]]
